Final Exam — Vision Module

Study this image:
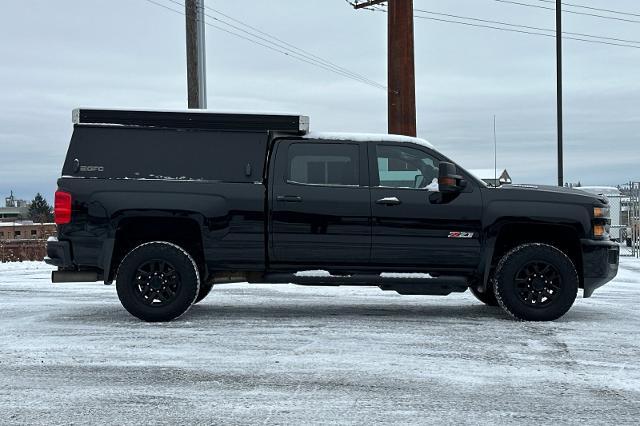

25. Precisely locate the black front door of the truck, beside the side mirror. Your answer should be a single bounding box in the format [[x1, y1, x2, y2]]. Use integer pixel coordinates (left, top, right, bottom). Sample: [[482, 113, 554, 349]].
[[369, 143, 482, 270]]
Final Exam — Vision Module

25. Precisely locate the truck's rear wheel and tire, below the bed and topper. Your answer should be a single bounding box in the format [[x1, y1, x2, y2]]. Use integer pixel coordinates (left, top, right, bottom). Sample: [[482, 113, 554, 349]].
[[116, 241, 200, 322]]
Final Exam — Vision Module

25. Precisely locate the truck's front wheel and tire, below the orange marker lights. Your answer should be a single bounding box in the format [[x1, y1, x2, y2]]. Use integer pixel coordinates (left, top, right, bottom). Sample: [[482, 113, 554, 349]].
[[494, 244, 579, 321]]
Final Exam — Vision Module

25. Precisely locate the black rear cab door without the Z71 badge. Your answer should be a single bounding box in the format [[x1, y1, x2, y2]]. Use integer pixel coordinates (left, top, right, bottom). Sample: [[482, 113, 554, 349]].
[[269, 140, 371, 266]]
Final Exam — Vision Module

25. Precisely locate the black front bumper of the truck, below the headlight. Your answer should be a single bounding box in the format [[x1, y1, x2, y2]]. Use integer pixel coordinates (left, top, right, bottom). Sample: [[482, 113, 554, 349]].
[[581, 240, 620, 297]]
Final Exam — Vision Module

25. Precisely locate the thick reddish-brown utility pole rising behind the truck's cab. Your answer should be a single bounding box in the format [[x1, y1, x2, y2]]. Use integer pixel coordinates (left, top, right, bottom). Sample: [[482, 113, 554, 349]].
[[353, 0, 416, 136]]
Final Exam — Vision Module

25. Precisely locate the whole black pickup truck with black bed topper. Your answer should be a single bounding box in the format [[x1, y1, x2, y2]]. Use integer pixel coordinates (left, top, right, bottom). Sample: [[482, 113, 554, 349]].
[[46, 109, 619, 321]]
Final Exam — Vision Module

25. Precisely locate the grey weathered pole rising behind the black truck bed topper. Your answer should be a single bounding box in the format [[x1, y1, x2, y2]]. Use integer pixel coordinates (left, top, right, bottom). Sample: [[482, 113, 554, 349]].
[[185, 0, 207, 109]]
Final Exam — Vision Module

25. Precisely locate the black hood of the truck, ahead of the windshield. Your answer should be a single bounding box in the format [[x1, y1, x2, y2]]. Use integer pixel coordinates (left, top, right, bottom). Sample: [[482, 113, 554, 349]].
[[496, 185, 609, 204]]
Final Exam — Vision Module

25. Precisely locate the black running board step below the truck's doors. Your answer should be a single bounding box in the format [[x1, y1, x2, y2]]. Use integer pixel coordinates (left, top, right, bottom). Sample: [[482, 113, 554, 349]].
[[260, 273, 469, 296]]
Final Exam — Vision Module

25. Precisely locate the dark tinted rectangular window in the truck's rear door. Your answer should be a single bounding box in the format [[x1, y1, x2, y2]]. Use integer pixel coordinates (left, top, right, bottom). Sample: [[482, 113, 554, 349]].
[[288, 142, 359, 186]]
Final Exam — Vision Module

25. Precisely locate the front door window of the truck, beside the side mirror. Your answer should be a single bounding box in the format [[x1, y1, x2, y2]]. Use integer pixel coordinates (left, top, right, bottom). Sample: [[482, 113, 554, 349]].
[[376, 145, 439, 190]]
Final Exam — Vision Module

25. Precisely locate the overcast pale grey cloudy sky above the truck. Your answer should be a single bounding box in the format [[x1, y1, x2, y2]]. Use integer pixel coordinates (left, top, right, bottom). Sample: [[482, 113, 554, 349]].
[[0, 0, 640, 198]]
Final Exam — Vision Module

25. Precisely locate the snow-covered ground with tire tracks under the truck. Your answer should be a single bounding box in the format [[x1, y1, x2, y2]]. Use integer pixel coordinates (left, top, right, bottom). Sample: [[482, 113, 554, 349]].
[[0, 258, 640, 424]]
